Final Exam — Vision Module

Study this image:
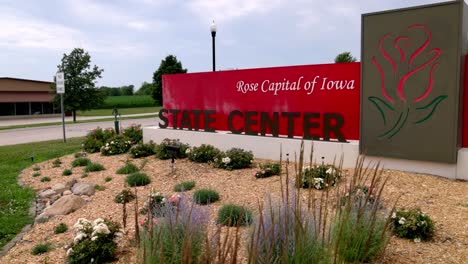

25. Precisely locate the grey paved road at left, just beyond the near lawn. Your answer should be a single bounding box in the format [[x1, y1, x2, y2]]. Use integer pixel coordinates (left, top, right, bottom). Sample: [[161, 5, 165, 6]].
[[0, 117, 159, 146]]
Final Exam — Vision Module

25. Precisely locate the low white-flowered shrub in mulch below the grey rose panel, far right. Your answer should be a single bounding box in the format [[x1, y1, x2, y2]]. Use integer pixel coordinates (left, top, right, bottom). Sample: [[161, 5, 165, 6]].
[[392, 208, 434, 242]]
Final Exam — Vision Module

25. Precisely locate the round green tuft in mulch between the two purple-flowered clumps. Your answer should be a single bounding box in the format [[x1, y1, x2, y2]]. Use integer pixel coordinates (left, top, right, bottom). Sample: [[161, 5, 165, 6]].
[[216, 204, 252, 226]]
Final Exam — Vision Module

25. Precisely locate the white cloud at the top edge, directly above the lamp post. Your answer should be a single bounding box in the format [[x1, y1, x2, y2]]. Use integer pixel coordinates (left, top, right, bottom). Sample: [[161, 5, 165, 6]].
[[189, 0, 281, 21]]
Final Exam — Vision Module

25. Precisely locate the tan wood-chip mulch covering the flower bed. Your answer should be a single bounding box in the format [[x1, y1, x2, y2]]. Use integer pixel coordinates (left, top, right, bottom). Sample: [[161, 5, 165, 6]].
[[0, 154, 468, 263]]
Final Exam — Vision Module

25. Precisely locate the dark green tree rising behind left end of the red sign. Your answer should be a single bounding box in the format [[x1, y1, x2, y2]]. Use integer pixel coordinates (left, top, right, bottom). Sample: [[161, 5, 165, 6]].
[[151, 55, 187, 105]]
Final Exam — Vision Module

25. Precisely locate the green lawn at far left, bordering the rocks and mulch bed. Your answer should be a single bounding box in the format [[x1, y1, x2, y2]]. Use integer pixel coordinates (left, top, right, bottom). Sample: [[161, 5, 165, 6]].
[[0, 138, 83, 248]]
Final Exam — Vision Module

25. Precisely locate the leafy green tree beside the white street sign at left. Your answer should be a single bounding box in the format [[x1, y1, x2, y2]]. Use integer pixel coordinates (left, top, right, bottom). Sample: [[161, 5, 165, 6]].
[[53, 48, 105, 122]]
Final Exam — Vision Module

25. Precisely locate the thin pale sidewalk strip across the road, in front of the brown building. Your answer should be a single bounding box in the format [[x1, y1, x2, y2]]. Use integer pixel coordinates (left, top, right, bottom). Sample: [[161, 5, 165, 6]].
[[0, 113, 155, 127]]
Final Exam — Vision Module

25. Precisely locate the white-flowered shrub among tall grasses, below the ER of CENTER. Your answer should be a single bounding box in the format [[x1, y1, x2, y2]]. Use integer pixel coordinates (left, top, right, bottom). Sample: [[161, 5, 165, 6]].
[[301, 164, 341, 190]]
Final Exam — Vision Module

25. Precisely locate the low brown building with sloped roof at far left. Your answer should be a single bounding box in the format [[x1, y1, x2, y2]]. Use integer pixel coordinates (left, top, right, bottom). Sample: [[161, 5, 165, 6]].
[[0, 77, 57, 116]]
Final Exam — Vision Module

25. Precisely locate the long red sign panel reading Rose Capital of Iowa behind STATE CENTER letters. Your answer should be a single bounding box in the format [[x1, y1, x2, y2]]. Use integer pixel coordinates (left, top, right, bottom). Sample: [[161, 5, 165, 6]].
[[160, 63, 360, 141]]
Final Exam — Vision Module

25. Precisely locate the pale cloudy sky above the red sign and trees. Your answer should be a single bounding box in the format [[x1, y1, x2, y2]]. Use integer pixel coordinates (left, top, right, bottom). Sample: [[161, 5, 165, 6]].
[[0, 0, 441, 88]]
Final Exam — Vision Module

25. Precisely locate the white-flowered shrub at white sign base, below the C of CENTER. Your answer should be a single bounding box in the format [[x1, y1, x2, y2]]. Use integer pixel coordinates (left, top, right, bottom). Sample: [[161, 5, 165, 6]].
[[213, 148, 254, 170]]
